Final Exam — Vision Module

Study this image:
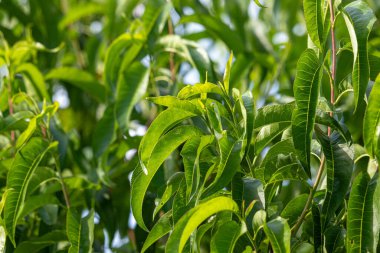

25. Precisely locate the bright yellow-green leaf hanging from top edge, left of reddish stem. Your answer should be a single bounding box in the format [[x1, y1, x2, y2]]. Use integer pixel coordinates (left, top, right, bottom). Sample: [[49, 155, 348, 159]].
[[303, 0, 324, 50]]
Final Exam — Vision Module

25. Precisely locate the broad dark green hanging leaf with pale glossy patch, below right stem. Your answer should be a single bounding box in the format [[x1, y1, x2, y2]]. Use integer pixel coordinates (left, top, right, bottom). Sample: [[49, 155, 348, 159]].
[[317, 132, 354, 229]]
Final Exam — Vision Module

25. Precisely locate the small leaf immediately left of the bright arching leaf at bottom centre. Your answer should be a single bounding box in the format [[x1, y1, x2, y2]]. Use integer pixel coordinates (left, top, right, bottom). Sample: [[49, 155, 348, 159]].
[[141, 212, 172, 253]]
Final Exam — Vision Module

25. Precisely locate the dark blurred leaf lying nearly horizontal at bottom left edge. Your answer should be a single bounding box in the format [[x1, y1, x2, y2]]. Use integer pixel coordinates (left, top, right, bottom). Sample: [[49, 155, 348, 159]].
[[14, 230, 67, 253]]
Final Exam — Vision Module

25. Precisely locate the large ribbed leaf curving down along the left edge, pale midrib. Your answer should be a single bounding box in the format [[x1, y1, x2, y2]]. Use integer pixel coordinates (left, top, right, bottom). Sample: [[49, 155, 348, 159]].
[[4, 137, 58, 245]]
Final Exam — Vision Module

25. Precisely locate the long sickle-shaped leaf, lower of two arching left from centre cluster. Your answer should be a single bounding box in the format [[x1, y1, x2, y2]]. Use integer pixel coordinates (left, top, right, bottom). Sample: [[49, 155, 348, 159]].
[[131, 125, 201, 230]]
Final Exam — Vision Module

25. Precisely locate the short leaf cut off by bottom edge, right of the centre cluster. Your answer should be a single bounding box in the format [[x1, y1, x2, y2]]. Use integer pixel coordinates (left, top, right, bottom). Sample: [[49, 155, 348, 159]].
[[264, 217, 290, 253]]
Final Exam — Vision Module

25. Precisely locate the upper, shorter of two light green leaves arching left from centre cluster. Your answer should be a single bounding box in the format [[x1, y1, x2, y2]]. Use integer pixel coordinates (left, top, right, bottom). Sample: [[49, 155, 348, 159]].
[[139, 108, 196, 167]]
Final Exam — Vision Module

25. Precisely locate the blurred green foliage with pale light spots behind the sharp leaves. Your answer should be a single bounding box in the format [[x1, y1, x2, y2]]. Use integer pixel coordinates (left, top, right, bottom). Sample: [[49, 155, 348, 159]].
[[0, 0, 380, 252]]
